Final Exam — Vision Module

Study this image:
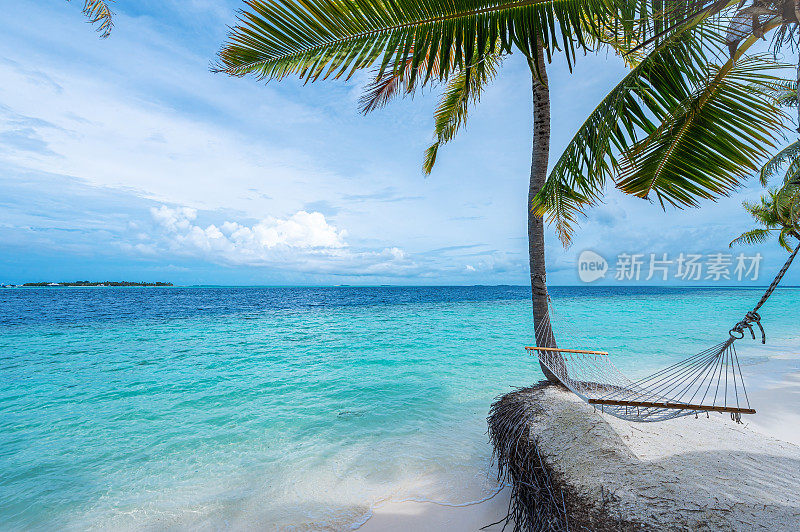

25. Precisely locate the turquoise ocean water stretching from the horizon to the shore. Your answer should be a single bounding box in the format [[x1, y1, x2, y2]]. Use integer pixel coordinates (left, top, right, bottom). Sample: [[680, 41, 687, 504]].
[[0, 286, 800, 530]]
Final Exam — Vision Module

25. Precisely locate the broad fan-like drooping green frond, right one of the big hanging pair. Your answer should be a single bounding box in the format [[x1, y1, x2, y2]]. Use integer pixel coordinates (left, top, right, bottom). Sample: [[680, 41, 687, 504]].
[[617, 52, 785, 207]]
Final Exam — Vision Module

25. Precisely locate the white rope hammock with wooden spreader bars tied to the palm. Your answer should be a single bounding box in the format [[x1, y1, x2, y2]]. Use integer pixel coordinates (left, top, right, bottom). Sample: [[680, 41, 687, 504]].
[[525, 245, 800, 423]]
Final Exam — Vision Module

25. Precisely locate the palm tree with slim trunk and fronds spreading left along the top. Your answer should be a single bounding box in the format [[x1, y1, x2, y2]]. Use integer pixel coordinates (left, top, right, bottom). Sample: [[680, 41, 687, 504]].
[[215, 0, 635, 380]]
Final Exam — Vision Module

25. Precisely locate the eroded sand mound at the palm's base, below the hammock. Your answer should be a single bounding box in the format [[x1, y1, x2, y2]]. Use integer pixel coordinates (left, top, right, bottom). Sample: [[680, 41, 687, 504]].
[[528, 386, 800, 532]]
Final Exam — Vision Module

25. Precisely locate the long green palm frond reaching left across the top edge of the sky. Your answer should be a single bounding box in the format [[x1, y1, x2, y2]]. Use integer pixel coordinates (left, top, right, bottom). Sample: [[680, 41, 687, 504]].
[[214, 0, 615, 86]]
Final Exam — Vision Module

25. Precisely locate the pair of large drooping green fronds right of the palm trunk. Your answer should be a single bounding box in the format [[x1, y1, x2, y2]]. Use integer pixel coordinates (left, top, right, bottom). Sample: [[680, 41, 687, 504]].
[[533, 0, 800, 245]]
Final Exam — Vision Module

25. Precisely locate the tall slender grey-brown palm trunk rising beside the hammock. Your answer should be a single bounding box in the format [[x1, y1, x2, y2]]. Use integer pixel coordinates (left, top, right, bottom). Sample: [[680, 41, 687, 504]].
[[528, 42, 558, 382]]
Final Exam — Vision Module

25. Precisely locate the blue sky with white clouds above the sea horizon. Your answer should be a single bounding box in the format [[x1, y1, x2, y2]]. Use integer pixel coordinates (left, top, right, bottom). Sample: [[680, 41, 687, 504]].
[[0, 0, 800, 284]]
